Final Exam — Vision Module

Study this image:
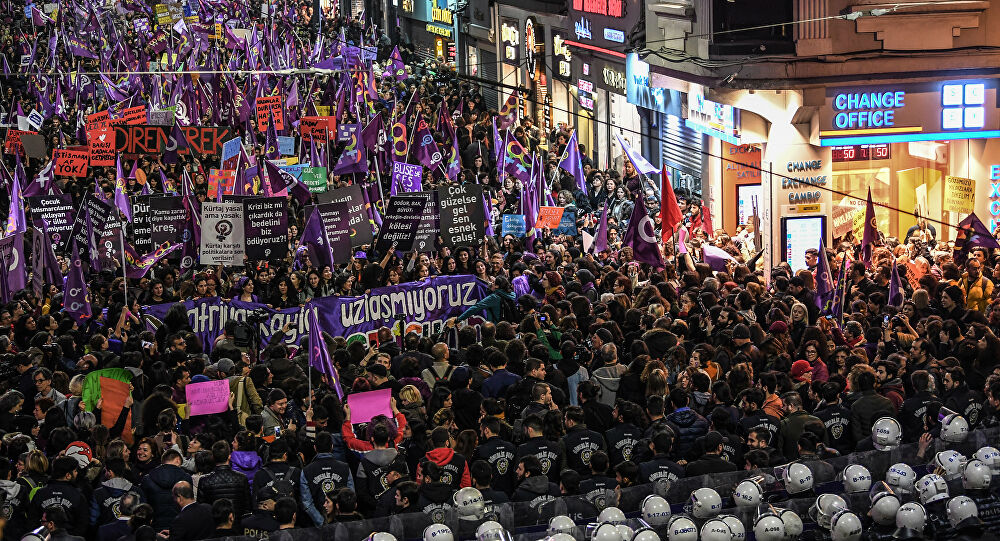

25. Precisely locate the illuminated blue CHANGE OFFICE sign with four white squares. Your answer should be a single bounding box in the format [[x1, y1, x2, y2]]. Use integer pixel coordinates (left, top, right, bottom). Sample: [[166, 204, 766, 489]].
[[819, 80, 1000, 146]]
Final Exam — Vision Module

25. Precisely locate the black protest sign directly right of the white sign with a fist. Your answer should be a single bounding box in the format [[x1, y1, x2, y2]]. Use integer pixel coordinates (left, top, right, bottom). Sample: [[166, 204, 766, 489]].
[[243, 197, 288, 261]]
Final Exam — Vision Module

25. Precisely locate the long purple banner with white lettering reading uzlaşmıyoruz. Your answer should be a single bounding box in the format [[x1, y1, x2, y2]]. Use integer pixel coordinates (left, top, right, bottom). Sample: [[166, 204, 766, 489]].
[[144, 275, 489, 351]]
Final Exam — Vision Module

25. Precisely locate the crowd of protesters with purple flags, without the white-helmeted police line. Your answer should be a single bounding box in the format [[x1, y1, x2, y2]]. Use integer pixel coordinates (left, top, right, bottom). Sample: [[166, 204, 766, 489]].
[[0, 0, 1000, 541]]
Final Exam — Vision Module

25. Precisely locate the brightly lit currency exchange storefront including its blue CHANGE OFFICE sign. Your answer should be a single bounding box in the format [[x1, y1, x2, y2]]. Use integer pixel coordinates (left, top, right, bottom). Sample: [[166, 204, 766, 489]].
[[819, 79, 1000, 240]]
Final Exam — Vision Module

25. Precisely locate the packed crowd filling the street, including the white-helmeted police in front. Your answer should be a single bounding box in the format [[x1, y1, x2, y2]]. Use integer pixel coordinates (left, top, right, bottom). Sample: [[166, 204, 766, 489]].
[[0, 2, 1000, 541]]
